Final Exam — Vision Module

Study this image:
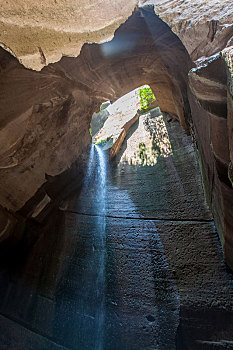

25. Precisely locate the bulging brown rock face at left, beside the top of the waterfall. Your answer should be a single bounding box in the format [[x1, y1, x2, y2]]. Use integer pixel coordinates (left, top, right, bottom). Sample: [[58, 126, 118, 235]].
[[0, 47, 93, 212]]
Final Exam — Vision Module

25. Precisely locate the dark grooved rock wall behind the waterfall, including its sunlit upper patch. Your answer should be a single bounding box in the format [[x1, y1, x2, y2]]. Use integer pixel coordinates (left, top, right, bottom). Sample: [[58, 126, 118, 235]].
[[0, 115, 233, 350]]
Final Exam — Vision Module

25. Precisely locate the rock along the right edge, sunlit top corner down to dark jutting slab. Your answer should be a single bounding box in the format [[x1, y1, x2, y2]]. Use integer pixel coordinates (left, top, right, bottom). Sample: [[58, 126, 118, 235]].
[[137, 0, 233, 267]]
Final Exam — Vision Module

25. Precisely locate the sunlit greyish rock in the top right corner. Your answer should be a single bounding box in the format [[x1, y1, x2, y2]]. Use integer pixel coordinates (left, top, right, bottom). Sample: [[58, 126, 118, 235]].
[[140, 0, 233, 61]]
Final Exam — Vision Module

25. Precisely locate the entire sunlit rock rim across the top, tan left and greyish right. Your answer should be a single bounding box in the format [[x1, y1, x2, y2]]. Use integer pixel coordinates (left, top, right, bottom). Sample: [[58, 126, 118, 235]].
[[0, 0, 232, 70]]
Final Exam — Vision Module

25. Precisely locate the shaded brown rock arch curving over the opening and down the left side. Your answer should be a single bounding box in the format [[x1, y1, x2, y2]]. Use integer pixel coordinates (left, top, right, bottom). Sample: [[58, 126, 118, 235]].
[[0, 9, 192, 228]]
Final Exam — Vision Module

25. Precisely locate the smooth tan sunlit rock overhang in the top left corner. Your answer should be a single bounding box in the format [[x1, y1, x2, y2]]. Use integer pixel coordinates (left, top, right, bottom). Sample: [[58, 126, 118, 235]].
[[0, 0, 137, 70]]
